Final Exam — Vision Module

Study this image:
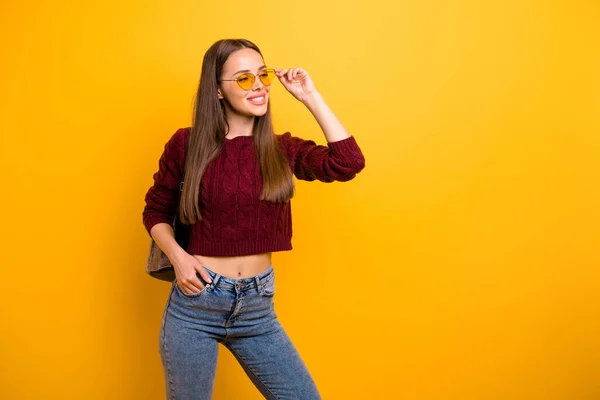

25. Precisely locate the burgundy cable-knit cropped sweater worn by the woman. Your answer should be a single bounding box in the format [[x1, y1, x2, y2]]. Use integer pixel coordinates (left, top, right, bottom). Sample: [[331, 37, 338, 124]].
[[142, 128, 365, 256]]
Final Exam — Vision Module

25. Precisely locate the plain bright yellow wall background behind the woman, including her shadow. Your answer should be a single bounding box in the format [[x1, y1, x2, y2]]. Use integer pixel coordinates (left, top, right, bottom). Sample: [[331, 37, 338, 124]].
[[0, 0, 600, 400]]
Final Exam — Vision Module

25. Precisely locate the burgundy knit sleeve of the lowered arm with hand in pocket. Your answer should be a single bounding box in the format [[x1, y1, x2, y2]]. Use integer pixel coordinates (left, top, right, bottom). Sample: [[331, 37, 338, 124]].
[[142, 129, 187, 237]]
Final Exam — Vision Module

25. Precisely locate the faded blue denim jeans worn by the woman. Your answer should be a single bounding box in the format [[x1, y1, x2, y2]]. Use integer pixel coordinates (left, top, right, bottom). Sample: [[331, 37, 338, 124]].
[[159, 265, 321, 400]]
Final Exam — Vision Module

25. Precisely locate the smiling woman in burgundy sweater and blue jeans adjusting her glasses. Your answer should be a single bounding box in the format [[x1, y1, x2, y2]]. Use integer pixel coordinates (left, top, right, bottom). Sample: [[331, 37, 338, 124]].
[[143, 39, 365, 400]]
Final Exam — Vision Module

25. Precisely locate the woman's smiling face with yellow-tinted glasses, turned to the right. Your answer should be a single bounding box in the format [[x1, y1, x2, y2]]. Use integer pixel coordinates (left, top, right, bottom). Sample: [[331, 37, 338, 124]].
[[218, 49, 270, 117]]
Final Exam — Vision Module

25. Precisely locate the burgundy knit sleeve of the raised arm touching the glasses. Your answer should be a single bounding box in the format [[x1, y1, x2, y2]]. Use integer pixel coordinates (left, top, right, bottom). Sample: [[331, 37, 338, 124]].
[[281, 132, 365, 182]]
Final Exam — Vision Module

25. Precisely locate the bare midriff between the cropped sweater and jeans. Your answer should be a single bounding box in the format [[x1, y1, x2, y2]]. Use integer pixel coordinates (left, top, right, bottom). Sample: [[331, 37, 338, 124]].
[[193, 253, 271, 279]]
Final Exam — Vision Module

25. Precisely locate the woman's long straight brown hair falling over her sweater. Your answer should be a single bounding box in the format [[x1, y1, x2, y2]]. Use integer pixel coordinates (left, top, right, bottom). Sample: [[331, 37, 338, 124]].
[[179, 39, 294, 224]]
